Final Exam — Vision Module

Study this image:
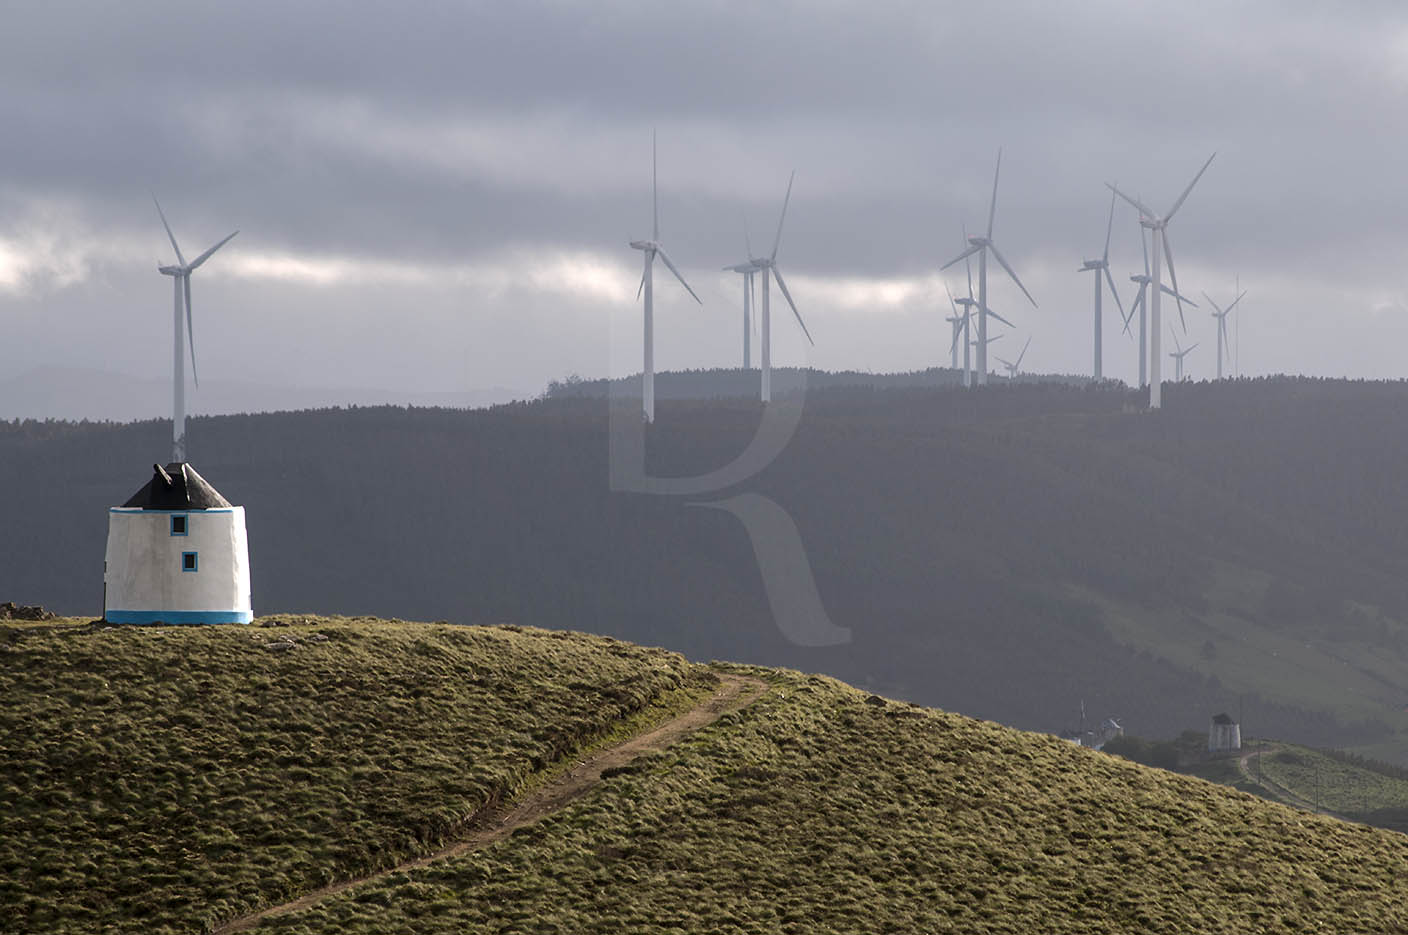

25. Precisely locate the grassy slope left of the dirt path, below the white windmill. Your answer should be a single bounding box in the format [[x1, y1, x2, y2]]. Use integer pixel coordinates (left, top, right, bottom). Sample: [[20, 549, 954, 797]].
[[0, 618, 712, 932]]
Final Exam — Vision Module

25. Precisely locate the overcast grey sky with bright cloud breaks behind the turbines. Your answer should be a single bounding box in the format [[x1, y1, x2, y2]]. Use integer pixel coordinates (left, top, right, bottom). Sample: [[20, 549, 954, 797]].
[[0, 0, 1408, 411]]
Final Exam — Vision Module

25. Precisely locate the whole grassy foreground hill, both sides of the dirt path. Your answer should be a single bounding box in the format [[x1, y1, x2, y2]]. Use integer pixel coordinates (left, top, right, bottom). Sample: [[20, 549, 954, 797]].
[[8, 620, 1408, 935]]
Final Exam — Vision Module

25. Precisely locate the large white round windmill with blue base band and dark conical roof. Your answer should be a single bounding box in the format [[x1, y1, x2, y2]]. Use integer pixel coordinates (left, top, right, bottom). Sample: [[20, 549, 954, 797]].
[[103, 462, 253, 624]]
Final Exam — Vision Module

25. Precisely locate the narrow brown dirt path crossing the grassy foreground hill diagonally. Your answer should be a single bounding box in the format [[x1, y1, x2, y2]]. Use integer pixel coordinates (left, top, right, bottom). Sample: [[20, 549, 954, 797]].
[[211, 673, 767, 935]]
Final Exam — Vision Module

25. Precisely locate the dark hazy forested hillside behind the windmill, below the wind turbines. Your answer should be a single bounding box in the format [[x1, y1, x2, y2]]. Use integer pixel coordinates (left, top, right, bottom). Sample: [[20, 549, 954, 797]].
[[8, 379, 1408, 760]]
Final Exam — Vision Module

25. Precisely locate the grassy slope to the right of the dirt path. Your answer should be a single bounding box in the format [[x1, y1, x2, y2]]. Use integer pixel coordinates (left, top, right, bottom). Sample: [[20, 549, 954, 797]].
[[259, 670, 1408, 935]]
